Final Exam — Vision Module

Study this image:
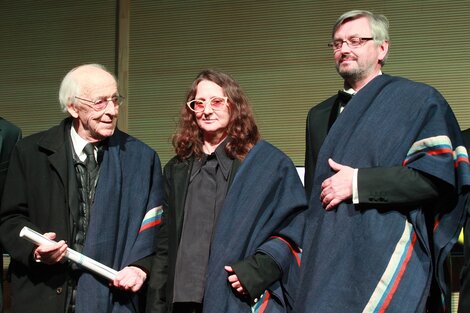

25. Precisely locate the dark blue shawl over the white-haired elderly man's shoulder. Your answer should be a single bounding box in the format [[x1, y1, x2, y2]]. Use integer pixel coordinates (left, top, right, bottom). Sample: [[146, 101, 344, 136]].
[[76, 130, 163, 313]]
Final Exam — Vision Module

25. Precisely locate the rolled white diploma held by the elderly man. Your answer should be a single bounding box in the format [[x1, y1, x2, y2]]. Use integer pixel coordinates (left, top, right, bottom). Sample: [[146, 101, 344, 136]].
[[20, 226, 117, 280]]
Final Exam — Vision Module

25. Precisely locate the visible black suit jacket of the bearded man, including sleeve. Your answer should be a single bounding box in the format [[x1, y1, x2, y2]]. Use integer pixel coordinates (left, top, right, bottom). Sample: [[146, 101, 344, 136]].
[[304, 95, 448, 205]]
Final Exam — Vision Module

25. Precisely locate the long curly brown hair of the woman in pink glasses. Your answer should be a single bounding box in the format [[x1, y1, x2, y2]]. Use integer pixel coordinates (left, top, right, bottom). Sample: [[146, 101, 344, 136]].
[[173, 69, 260, 160]]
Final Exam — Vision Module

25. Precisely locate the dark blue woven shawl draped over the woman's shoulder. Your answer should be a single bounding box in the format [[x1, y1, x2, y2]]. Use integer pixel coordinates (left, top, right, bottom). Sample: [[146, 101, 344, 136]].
[[204, 141, 306, 313]]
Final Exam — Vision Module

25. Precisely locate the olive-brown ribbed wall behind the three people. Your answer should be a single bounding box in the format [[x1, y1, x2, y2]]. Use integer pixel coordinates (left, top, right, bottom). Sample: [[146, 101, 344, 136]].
[[0, 0, 470, 165]]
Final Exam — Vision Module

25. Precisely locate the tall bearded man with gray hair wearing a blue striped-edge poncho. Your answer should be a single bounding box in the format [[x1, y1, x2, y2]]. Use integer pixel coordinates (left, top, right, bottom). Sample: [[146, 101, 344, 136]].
[[300, 10, 470, 313]]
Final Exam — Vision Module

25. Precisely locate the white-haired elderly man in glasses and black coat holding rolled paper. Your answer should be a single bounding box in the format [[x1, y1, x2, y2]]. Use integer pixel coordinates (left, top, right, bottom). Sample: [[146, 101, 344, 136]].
[[0, 64, 162, 313]]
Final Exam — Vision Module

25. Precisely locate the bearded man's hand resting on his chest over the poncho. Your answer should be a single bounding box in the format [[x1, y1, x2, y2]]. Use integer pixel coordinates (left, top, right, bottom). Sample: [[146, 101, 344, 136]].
[[320, 159, 354, 211]]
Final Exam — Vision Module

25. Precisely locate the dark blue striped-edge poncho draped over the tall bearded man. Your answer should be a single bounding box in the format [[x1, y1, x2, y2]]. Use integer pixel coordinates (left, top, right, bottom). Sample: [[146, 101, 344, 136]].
[[294, 75, 470, 313]]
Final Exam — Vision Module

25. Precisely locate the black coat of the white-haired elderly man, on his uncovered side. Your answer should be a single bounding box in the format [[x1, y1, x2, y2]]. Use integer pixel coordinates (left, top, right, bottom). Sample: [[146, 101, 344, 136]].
[[0, 117, 77, 313]]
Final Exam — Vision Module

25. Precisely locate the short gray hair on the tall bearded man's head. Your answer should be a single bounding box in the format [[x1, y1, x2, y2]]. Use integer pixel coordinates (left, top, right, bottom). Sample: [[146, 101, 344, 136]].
[[331, 10, 390, 66]]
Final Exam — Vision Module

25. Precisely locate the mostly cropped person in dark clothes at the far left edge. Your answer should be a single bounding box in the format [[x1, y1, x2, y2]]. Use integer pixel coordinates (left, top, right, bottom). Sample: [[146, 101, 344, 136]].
[[0, 117, 21, 312]]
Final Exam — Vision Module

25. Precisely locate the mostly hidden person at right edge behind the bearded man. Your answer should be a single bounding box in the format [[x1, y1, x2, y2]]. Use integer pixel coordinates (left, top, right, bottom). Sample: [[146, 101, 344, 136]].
[[458, 128, 470, 313]]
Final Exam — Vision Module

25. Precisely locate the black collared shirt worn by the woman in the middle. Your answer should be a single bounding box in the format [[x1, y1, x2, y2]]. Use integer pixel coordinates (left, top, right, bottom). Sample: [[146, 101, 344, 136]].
[[173, 141, 233, 303]]
